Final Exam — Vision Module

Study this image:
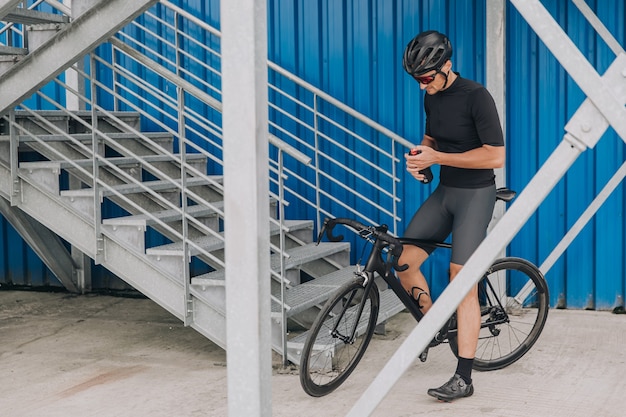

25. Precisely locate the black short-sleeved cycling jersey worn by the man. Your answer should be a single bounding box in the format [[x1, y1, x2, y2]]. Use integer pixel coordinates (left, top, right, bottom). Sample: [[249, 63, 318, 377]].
[[424, 73, 504, 188]]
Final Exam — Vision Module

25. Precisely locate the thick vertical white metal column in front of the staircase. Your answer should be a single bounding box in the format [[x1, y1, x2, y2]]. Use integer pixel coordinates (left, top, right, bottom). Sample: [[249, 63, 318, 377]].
[[221, 0, 272, 417]]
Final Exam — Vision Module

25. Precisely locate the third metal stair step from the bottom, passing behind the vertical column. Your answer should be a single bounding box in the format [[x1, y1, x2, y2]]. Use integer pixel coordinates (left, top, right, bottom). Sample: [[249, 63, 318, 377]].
[[191, 242, 350, 287]]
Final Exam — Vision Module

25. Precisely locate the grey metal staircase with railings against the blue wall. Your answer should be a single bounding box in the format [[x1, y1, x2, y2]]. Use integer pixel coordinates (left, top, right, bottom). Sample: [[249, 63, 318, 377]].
[[0, 0, 402, 362]]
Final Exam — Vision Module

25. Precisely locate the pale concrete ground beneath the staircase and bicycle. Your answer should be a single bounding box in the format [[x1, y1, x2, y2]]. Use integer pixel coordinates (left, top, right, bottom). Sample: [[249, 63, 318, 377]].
[[0, 291, 626, 417]]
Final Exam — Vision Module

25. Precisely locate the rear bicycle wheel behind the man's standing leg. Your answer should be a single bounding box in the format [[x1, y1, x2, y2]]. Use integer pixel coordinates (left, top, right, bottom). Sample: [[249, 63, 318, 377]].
[[448, 257, 550, 371]]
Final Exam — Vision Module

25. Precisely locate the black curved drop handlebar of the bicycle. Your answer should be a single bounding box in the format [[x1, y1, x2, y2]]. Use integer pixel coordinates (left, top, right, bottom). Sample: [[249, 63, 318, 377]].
[[317, 217, 409, 271]]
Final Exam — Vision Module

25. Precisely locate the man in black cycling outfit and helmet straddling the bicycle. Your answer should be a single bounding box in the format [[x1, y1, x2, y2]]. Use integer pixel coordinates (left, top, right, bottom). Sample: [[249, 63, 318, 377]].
[[398, 31, 505, 401]]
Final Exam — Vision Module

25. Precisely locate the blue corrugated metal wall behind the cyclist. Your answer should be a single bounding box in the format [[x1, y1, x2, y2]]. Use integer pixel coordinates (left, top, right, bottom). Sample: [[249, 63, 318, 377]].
[[0, 0, 626, 309]]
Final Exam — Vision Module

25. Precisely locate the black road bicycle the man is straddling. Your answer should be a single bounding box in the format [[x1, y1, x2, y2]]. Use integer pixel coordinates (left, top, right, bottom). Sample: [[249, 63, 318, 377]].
[[300, 188, 549, 397]]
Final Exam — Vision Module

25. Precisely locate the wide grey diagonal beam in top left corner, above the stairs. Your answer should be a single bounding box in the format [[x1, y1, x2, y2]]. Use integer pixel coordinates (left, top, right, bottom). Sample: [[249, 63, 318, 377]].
[[0, 0, 157, 114]]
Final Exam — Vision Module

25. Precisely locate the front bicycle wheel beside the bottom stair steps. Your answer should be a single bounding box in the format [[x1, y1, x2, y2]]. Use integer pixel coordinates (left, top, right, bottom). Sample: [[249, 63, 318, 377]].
[[300, 278, 380, 397]]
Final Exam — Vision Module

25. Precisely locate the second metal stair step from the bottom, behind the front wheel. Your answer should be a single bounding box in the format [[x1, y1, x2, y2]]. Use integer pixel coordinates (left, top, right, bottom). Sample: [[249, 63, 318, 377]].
[[272, 265, 356, 317]]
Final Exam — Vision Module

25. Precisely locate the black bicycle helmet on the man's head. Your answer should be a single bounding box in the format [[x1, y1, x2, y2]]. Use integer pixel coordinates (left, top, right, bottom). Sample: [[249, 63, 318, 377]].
[[402, 30, 452, 77]]
